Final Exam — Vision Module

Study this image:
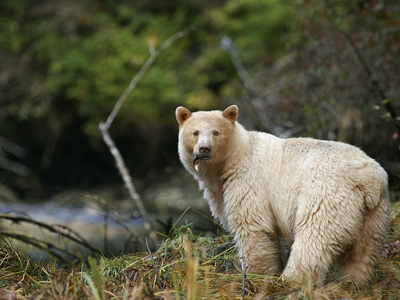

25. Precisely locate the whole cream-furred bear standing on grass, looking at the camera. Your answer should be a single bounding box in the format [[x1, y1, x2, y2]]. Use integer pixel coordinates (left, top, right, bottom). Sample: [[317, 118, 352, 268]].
[[176, 105, 390, 286]]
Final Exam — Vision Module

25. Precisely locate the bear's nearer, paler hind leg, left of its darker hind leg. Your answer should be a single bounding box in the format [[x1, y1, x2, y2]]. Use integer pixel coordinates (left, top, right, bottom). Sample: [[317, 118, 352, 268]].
[[283, 193, 354, 284]]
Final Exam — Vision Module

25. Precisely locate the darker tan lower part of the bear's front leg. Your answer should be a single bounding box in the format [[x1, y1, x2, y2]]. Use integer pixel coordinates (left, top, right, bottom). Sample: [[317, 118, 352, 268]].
[[235, 231, 282, 275]]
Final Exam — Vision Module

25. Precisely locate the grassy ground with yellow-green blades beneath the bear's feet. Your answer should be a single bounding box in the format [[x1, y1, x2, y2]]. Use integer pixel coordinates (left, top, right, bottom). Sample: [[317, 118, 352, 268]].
[[0, 202, 400, 300]]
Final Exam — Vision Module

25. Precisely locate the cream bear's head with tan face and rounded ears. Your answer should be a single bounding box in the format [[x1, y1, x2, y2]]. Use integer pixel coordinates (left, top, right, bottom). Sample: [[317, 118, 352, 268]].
[[175, 105, 239, 171]]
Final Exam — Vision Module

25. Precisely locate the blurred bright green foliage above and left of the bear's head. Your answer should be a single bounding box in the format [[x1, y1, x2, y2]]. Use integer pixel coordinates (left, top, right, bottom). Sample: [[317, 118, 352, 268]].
[[0, 0, 293, 134]]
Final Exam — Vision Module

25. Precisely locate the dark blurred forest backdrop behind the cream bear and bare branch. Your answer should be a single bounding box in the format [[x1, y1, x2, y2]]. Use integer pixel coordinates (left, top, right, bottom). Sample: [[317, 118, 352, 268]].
[[0, 0, 400, 200]]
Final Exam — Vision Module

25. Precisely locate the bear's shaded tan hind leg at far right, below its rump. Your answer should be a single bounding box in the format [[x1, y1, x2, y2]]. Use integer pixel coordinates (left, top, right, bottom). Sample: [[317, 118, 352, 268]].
[[338, 197, 388, 286]]
